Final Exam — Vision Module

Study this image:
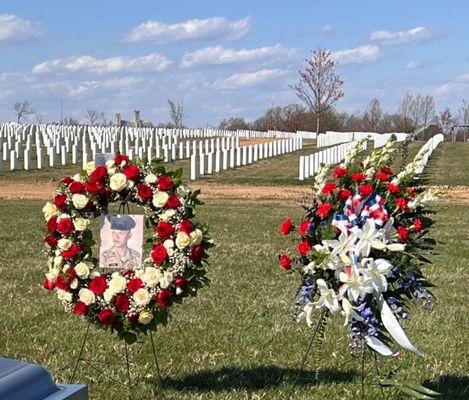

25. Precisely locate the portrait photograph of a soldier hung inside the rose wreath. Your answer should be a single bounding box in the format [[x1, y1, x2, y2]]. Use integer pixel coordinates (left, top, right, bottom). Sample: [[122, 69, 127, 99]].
[[99, 214, 144, 270]]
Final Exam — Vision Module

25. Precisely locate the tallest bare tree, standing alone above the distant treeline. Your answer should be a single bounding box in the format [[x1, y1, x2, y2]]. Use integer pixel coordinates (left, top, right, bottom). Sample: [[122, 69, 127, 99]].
[[290, 48, 344, 133]]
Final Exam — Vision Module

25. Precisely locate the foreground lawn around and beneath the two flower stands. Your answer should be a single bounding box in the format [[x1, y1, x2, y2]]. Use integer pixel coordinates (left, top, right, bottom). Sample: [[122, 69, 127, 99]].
[[0, 200, 469, 400]]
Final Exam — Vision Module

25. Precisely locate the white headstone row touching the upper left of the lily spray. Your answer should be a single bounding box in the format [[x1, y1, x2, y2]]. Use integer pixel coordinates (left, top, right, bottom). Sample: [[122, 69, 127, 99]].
[[298, 141, 366, 181]]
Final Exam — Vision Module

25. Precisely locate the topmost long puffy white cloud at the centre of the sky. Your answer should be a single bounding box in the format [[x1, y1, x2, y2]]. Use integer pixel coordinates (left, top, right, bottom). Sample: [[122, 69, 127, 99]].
[[124, 17, 251, 44]]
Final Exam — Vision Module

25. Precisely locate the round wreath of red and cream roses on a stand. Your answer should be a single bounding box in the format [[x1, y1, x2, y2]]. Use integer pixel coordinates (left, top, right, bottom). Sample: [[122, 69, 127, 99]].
[[43, 155, 213, 342]]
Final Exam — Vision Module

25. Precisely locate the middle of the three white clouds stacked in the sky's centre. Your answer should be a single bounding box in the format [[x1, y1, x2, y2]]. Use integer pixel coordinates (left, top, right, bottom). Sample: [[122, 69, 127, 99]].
[[181, 44, 294, 68]]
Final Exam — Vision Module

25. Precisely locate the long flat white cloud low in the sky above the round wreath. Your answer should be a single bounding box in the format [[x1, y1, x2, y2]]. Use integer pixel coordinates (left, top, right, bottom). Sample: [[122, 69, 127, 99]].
[[33, 53, 172, 75]]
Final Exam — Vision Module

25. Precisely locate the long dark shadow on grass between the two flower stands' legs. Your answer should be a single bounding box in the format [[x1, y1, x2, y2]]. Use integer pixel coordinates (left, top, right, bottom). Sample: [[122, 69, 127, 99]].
[[163, 366, 356, 392]]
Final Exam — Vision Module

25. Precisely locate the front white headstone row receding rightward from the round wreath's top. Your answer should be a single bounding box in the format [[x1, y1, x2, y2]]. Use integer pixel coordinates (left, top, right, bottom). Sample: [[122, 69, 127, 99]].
[[191, 136, 303, 180]]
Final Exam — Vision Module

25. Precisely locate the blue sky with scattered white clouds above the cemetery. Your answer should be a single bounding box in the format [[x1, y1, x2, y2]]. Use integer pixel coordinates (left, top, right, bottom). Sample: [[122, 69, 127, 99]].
[[0, 0, 469, 127]]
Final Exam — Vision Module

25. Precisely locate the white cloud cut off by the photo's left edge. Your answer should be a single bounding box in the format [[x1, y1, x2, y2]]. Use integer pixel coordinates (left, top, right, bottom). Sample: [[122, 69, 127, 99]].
[[0, 14, 43, 45]]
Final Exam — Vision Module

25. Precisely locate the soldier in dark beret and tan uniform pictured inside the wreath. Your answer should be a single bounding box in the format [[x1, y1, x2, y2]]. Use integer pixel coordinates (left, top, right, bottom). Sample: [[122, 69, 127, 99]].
[[101, 214, 141, 270]]
